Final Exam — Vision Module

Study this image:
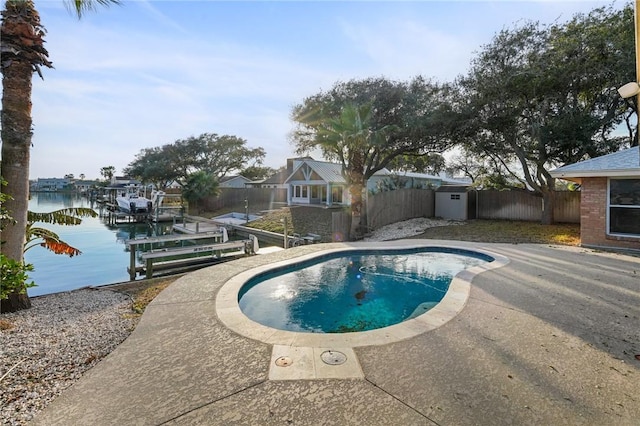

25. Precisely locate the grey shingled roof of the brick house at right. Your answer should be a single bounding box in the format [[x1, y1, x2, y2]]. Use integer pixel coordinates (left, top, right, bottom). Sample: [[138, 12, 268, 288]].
[[549, 146, 640, 181]]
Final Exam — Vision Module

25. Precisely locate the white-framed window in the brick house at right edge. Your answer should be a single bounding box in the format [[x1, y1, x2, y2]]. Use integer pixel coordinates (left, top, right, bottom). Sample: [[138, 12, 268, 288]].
[[608, 179, 640, 236]]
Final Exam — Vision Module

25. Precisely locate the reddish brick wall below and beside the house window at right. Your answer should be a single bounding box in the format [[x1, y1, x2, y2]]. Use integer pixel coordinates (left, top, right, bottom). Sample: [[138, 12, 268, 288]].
[[580, 177, 640, 249]]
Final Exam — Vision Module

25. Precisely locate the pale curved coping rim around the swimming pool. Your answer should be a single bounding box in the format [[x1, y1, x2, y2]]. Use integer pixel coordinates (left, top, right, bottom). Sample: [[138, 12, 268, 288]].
[[215, 240, 509, 350]]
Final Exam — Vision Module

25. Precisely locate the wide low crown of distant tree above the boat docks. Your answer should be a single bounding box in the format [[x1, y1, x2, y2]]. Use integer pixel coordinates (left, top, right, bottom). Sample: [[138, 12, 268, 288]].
[[124, 133, 265, 188]]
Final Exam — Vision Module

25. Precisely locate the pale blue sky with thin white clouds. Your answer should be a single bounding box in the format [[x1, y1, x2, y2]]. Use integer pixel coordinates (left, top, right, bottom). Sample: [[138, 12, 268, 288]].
[[25, 0, 624, 179]]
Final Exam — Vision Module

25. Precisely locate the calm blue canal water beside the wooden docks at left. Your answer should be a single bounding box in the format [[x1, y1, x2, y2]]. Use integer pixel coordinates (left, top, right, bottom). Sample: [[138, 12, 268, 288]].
[[25, 192, 171, 296]]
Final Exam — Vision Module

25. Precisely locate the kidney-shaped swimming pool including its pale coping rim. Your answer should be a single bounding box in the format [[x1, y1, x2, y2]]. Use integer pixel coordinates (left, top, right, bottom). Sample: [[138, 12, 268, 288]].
[[216, 240, 509, 348]]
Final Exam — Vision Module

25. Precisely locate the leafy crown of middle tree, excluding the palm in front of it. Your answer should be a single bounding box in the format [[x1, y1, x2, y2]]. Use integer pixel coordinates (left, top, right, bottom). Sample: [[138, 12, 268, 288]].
[[290, 77, 453, 178]]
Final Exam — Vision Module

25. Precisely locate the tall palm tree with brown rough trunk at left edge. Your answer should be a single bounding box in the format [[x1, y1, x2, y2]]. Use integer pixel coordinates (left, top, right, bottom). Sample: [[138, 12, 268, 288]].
[[0, 0, 119, 309]]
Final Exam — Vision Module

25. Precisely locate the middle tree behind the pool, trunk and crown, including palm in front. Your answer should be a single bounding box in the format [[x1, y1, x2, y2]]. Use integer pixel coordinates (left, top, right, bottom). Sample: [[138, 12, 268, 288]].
[[290, 77, 452, 238]]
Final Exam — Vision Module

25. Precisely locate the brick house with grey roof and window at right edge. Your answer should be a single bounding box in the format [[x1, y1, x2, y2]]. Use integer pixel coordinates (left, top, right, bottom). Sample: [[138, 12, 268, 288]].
[[550, 146, 640, 250]]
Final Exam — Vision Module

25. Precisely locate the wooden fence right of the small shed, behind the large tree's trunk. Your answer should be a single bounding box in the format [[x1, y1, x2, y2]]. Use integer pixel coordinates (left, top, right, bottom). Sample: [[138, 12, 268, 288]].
[[476, 191, 580, 223]]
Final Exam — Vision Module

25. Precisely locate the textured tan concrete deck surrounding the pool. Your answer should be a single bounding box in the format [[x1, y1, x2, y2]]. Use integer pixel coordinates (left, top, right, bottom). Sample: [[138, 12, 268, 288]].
[[34, 240, 640, 425]]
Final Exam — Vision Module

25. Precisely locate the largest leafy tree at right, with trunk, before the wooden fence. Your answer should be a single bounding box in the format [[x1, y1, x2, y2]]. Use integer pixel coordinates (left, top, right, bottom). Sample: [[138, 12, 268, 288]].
[[453, 6, 635, 223]]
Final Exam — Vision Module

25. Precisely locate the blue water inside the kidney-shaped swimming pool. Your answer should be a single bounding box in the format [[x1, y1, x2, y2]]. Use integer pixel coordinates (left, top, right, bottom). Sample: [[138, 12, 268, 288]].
[[238, 248, 493, 333]]
